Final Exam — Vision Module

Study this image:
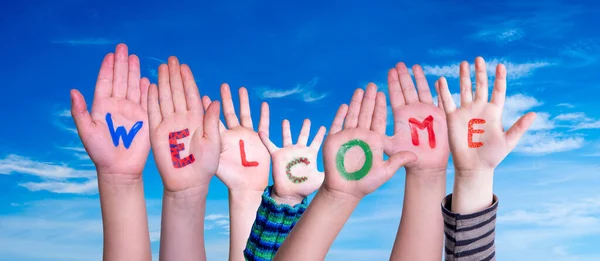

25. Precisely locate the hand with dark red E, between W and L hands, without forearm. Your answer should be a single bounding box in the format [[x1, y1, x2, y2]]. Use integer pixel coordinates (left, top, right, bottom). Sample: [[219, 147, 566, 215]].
[[148, 57, 221, 192]]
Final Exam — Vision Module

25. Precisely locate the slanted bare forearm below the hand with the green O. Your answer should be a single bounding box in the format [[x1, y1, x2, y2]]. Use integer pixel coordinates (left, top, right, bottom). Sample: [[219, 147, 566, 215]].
[[273, 187, 359, 260]]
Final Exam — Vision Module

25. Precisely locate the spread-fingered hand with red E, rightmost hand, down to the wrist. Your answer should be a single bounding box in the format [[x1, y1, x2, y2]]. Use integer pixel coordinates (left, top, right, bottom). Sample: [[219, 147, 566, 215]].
[[439, 57, 536, 175]]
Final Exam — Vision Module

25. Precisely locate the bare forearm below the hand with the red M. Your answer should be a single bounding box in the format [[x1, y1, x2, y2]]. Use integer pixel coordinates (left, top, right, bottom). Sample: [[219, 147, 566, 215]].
[[390, 171, 446, 260]]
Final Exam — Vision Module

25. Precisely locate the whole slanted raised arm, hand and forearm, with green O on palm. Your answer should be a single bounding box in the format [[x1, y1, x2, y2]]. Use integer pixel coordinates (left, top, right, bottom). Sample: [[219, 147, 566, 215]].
[[274, 84, 416, 260]]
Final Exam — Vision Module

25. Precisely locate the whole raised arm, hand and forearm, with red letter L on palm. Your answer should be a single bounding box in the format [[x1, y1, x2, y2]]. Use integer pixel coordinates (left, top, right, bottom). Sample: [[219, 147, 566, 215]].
[[202, 84, 271, 261]]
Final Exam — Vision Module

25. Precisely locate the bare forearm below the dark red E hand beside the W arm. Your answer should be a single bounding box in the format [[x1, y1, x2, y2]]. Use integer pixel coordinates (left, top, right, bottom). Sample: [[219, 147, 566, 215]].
[[159, 187, 208, 261]]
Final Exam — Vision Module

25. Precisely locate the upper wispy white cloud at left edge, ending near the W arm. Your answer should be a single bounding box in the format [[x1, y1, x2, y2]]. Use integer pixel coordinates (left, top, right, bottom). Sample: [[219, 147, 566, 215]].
[[0, 154, 96, 179]]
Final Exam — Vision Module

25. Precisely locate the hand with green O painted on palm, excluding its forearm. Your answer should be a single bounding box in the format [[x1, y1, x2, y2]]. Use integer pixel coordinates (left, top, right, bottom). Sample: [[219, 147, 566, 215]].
[[323, 83, 417, 199]]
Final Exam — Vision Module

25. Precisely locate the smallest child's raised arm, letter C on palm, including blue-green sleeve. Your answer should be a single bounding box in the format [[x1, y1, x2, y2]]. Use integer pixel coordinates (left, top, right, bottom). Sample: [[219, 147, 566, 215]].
[[244, 119, 325, 260]]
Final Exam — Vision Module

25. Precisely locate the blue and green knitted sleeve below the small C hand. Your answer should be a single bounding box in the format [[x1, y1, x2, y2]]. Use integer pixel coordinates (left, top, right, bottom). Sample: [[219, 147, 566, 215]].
[[244, 186, 307, 261]]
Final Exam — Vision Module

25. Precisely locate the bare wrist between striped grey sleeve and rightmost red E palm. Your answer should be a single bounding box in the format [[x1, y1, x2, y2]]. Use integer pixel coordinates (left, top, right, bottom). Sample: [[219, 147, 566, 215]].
[[452, 169, 494, 215]]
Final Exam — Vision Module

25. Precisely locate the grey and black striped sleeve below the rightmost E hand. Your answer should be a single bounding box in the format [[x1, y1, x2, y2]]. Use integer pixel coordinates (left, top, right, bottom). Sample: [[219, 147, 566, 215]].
[[442, 194, 498, 261]]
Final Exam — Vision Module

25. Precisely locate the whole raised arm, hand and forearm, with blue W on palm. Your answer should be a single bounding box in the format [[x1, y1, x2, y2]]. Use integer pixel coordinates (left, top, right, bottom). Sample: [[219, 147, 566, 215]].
[[71, 44, 151, 261]]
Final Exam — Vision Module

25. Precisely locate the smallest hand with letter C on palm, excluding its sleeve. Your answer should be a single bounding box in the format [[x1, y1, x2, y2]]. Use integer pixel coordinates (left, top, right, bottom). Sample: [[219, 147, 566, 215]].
[[258, 119, 325, 206]]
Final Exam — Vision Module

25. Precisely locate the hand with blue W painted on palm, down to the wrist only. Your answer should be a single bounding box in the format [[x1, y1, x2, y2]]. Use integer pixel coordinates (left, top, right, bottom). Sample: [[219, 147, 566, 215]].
[[71, 44, 150, 177]]
